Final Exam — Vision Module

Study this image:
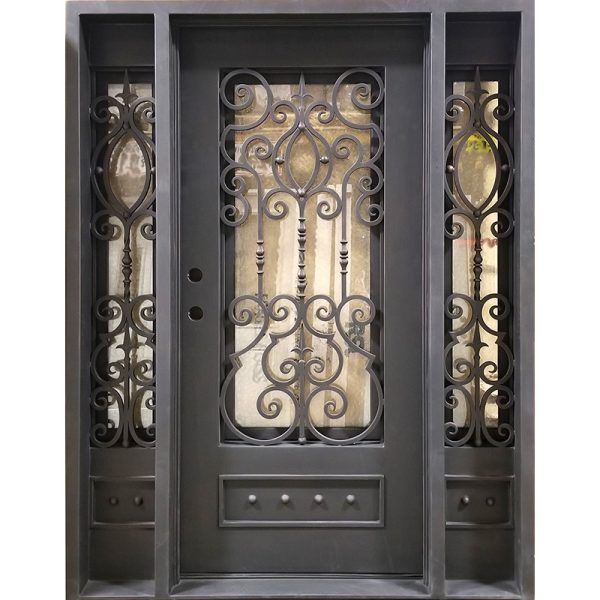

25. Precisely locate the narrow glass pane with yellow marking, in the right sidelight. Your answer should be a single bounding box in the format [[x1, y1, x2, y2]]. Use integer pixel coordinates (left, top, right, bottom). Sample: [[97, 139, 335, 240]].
[[446, 71, 513, 445]]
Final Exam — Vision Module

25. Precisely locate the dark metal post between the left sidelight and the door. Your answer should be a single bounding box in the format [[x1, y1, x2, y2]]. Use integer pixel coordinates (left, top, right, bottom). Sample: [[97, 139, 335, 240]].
[[154, 11, 178, 598]]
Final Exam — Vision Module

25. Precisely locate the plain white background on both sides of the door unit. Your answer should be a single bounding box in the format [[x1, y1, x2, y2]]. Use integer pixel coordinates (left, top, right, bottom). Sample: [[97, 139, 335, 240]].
[[0, 0, 600, 600]]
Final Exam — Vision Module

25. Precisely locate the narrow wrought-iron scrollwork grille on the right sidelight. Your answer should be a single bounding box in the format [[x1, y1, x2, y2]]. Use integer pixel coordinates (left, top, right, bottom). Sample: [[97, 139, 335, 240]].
[[444, 68, 515, 446]]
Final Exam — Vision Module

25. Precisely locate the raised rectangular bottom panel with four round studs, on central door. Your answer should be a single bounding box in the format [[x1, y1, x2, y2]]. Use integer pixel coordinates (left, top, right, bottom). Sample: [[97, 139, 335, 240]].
[[219, 475, 384, 527]]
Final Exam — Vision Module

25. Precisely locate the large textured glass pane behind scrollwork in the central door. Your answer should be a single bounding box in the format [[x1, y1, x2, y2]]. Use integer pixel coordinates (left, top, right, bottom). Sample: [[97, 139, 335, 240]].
[[222, 69, 383, 442]]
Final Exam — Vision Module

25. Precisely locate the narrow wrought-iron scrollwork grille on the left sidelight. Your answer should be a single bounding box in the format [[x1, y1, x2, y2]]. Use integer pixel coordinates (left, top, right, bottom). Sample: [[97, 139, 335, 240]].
[[90, 71, 156, 447]]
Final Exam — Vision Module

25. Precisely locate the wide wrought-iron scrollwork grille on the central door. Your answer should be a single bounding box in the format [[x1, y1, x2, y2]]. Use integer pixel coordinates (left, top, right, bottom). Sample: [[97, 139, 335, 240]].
[[220, 68, 385, 445]]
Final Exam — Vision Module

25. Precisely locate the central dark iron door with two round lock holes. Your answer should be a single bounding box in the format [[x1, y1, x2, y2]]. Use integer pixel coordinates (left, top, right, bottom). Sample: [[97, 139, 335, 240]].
[[178, 22, 424, 576]]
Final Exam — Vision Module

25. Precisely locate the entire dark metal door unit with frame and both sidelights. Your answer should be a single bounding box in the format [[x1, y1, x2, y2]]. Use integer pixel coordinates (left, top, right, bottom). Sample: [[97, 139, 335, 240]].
[[66, 0, 534, 600]]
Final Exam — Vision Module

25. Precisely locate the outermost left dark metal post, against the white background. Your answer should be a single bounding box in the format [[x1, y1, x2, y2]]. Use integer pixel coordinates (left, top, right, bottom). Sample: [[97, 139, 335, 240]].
[[65, 5, 92, 598]]
